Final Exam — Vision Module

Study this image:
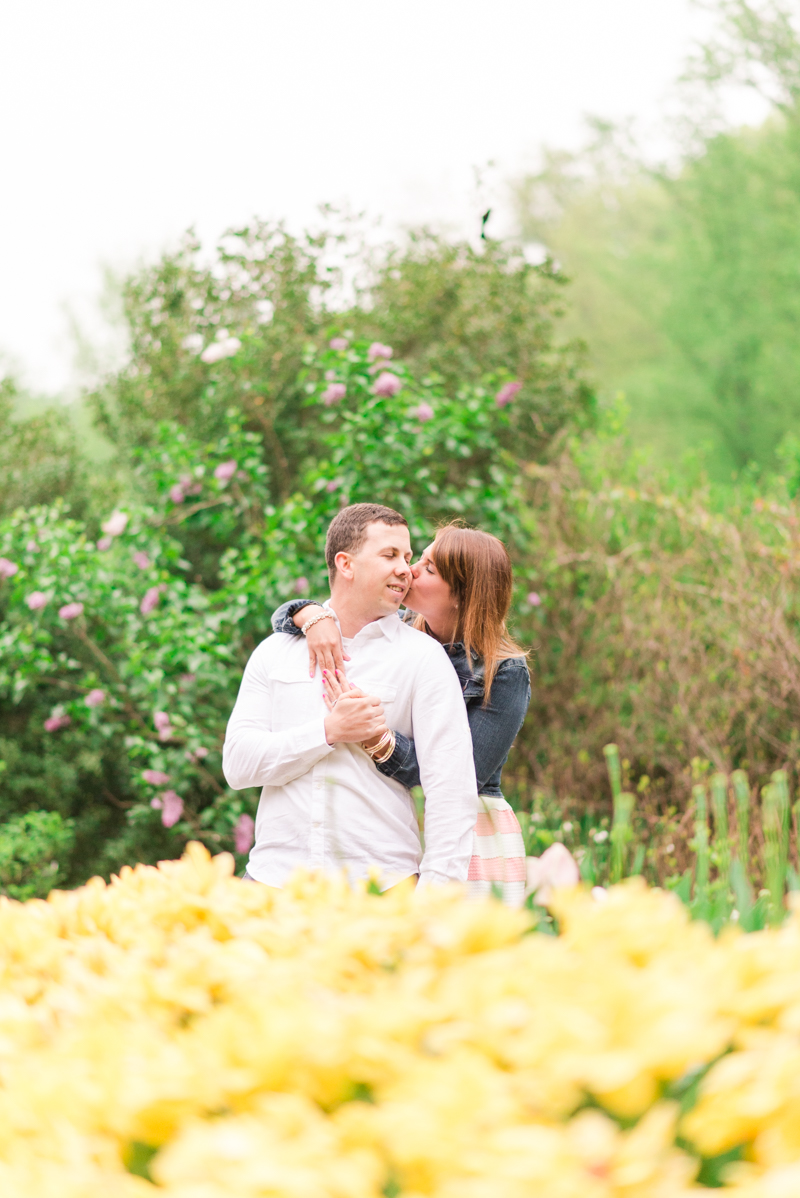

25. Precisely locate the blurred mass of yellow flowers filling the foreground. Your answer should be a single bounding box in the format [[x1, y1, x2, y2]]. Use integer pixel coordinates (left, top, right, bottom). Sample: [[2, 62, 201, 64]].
[[0, 845, 800, 1198]]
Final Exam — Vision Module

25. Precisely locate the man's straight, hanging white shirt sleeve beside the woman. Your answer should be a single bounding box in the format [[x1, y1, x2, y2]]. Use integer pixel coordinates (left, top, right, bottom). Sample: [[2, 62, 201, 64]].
[[412, 646, 478, 887]]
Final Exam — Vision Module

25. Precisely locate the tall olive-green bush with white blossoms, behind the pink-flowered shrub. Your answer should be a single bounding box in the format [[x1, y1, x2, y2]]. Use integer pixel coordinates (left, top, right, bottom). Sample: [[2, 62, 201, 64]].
[[91, 223, 592, 502]]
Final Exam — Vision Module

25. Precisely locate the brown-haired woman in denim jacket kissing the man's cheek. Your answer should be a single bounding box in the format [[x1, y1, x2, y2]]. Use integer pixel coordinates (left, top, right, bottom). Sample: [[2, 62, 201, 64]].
[[272, 525, 531, 906]]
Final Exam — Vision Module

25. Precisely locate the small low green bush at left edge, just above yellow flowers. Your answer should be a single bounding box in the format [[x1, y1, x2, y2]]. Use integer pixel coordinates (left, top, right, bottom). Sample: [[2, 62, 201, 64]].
[[0, 811, 74, 900]]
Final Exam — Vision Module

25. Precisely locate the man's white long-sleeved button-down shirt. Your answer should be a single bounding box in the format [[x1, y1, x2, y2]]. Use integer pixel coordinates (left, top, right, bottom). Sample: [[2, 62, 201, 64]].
[[223, 605, 478, 887]]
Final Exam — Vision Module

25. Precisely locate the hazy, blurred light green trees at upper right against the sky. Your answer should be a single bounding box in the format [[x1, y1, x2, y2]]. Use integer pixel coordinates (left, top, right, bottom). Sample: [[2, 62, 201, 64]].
[[517, 0, 800, 479]]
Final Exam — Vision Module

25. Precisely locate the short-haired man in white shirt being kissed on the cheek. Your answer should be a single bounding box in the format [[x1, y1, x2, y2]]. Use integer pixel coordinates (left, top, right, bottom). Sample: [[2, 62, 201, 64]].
[[223, 503, 478, 888]]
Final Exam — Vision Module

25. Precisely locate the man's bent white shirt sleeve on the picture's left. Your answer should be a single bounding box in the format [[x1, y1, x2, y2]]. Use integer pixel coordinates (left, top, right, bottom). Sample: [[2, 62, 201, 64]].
[[223, 637, 333, 791]]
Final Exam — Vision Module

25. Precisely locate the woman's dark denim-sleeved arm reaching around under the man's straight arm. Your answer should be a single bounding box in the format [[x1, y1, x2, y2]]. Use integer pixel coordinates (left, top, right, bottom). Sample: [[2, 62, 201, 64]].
[[377, 667, 531, 793]]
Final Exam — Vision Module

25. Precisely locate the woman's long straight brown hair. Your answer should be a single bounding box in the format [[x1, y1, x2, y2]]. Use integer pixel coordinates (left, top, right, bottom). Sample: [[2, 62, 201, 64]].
[[414, 525, 526, 702]]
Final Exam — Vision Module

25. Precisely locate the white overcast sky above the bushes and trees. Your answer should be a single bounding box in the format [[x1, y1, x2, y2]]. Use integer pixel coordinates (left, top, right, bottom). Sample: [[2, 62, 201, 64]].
[[0, 0, 701, 392]]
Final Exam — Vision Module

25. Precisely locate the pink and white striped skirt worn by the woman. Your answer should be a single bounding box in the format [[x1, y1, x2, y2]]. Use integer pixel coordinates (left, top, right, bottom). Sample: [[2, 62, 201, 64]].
[[467, 794, 526, 907]]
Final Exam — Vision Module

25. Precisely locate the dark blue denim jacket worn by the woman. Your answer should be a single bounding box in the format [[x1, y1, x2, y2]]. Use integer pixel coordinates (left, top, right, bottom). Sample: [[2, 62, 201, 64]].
[[272, 599, 531, 797]]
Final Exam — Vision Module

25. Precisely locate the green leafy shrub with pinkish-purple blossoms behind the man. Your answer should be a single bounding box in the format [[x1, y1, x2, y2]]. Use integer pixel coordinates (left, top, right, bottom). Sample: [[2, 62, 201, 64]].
[[0, 338, 536, 881]]
